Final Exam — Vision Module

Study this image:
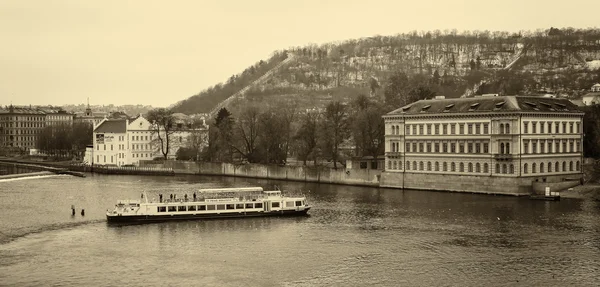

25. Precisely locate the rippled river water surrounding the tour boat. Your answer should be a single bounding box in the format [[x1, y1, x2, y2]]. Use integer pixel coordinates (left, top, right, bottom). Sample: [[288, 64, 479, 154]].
[[0, 168, 600, 286]]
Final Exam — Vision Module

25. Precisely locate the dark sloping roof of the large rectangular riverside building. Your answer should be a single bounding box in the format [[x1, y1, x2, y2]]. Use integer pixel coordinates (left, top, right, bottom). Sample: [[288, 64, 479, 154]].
[[387, 96, 581, 115]]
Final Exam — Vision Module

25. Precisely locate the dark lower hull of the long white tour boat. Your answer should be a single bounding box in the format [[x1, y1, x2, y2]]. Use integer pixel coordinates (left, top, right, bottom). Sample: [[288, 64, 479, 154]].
[[106, 207, 310, 224]]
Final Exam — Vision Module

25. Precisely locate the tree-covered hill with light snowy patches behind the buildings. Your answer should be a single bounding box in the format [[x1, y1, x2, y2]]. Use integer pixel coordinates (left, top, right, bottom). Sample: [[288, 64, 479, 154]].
[[172, 28, 600, 113]]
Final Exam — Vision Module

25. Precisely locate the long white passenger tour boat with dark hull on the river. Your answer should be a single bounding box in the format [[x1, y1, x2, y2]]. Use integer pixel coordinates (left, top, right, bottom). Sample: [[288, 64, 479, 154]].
[[106, 187, 310, 223]]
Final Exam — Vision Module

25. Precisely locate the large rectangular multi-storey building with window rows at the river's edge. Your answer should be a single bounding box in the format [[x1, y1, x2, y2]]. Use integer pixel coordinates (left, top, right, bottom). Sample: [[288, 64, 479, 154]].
[[381, 96, 583, 194]]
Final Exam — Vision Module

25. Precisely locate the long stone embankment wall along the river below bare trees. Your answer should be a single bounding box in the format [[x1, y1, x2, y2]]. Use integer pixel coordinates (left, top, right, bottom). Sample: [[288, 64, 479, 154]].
[[142, 161, 381, 186]]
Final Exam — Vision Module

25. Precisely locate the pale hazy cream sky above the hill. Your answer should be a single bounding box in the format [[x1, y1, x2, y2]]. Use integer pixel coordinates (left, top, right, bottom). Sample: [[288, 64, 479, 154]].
[[0, 0, 600, 107]]
